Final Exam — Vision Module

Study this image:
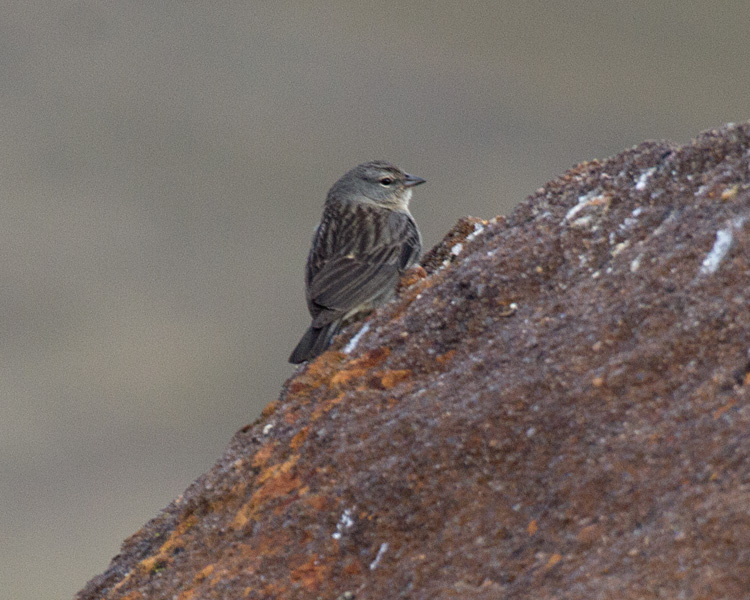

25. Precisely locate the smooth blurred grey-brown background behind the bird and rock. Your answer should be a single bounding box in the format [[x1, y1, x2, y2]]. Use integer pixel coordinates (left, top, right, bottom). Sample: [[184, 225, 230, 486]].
[[0, 0, 750, 600]]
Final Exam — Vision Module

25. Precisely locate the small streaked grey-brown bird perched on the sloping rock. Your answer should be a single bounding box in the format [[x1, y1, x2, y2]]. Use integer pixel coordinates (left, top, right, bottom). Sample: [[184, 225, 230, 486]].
[[289, 161, 425, 364]]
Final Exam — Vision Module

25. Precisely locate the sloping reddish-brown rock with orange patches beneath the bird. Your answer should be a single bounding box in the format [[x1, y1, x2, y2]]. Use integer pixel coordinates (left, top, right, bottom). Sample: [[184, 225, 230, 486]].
[[78, 124, 750, 600]]
